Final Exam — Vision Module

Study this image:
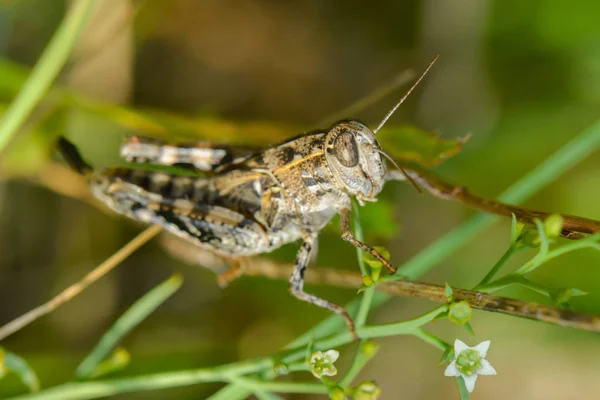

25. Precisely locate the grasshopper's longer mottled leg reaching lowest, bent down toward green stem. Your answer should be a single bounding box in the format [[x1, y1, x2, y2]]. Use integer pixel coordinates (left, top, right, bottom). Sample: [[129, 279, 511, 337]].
[[289, 233, 358, 341]]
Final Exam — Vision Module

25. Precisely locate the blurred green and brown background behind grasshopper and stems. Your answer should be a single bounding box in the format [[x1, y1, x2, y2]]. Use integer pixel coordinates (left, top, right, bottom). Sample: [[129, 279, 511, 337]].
[[0, 0, 600, 399]]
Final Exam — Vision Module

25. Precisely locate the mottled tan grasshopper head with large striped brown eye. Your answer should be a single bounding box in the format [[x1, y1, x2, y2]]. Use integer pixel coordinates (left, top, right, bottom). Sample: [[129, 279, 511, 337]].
[[325, 121, 386, 202]]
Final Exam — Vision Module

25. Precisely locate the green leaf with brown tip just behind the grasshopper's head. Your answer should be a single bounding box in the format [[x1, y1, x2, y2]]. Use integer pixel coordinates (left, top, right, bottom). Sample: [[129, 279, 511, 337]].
[[377, 125, 465, 166]]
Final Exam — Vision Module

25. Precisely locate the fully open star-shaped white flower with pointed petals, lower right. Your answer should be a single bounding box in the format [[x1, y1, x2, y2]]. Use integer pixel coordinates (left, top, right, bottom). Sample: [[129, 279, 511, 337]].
[[444, 339, 496, 392]]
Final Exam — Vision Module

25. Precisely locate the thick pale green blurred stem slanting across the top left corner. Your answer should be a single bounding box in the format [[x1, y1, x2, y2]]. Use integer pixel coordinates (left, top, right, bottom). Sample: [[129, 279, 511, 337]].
[[0, 0, 98, 152]]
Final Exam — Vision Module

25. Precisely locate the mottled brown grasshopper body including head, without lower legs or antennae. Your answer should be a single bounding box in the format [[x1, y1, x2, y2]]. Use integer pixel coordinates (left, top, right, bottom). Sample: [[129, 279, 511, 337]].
[[92, 121, 385, 256]]
